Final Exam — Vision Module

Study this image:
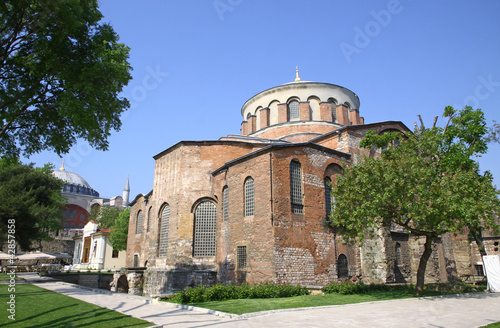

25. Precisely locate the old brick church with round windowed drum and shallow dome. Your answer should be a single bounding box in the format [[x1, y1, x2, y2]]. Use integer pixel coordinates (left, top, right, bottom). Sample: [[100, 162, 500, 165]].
[[127, 71, 498, 295]]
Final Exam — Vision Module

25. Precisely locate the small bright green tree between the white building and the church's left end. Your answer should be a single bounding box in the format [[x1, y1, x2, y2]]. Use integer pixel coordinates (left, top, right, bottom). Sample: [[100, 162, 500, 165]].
[[90, 206, 130, 251]]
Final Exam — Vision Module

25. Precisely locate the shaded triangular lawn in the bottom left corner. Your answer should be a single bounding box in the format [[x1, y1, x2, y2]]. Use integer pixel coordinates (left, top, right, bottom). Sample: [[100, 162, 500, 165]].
[[0, 284, 153, 328]]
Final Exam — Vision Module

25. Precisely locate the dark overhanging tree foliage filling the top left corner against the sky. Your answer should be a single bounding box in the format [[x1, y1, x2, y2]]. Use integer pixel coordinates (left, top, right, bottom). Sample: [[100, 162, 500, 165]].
[[0, 0, 131, 156]]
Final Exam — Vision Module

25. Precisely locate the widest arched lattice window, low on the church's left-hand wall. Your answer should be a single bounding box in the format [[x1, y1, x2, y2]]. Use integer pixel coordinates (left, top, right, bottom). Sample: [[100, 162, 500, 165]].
[[193, 201, 217, 256]]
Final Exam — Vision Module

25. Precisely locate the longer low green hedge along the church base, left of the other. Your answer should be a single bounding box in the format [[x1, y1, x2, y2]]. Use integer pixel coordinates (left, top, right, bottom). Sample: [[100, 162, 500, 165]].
[[168, 283, 309, 304]]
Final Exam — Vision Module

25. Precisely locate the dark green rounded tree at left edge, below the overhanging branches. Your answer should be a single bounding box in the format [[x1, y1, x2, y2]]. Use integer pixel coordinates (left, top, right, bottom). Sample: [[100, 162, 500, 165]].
[[0, 159, 65, 250]]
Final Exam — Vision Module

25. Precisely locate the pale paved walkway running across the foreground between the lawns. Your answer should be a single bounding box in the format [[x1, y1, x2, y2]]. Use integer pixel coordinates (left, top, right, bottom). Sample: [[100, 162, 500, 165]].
[[19, 274, 500, 328]]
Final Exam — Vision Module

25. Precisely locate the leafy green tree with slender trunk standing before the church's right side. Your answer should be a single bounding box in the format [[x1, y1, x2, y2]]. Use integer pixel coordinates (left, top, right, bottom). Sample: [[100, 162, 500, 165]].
[[330, 107, 499, 295]]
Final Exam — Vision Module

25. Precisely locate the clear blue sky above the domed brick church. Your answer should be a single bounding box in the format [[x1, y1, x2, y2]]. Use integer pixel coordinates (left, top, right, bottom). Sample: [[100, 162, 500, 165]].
[[25, 0, 500, 199]]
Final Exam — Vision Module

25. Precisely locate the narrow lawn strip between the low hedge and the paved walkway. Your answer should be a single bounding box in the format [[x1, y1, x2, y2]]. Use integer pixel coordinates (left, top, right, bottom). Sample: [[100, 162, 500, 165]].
[[173, 287, 484, 314]]
